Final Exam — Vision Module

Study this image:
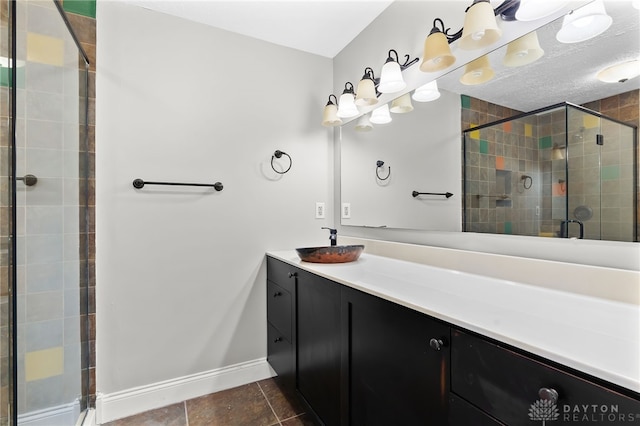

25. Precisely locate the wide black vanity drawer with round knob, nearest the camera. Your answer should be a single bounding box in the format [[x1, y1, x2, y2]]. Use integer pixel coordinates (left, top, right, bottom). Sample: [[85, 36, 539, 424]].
[[451, 330, 640, 426]]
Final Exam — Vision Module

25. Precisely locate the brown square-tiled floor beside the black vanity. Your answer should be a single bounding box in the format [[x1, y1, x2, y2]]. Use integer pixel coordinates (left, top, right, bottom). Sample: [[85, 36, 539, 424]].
[[103, 379, 315, 426]]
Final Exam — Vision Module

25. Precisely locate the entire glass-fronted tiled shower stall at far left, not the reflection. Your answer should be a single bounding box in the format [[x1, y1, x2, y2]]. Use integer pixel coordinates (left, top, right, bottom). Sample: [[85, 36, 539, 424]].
[[0, 0, 89, 426]]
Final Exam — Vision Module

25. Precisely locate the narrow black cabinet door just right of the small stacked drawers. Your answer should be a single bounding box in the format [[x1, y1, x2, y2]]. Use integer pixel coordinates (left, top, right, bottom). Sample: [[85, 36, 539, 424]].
[[296, 271, 341, 426]]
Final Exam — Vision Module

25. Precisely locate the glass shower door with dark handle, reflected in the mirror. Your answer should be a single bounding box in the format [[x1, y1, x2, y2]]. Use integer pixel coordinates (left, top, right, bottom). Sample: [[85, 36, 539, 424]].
[[565, 106, 635, 241]]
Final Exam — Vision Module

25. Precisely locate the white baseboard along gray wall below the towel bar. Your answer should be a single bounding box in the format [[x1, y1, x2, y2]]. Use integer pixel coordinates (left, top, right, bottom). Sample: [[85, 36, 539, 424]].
[[96, 358, 275, 424]]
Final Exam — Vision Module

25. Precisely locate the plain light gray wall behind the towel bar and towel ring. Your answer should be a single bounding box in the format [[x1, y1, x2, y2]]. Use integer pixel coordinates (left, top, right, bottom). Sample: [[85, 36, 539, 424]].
[[96, 2, 333, 393]]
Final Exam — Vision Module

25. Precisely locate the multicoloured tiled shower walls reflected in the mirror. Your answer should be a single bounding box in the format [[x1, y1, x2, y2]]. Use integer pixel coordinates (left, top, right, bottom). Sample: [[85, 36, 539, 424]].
[[462, 90, 639, 241]]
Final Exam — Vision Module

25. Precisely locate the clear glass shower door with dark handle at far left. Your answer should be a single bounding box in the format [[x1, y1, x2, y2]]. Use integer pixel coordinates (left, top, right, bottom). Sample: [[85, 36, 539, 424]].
[[14, 1, 86, 425]]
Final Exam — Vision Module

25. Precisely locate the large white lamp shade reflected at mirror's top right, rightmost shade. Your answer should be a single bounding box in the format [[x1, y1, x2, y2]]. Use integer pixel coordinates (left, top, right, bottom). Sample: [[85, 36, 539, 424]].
[[556, 0, 613, 43]]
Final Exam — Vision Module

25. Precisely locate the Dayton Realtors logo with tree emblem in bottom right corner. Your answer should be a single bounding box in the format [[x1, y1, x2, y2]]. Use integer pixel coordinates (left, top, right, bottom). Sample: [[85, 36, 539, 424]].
[[529, 399, 640, 426]]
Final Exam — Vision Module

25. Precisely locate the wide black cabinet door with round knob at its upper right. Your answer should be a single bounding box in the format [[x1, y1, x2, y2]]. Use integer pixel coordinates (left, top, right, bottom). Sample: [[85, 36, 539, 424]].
[[344, 289, 449, 426]]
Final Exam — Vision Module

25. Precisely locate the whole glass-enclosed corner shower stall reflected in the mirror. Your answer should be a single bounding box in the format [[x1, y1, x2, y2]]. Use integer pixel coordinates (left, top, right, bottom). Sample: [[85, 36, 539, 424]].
[[463, 103, 638, 241]]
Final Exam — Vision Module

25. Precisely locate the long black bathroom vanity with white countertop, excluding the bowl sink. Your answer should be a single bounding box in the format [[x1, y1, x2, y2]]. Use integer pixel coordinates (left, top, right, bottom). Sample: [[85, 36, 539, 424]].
[[267, 251, 640, 426]]
